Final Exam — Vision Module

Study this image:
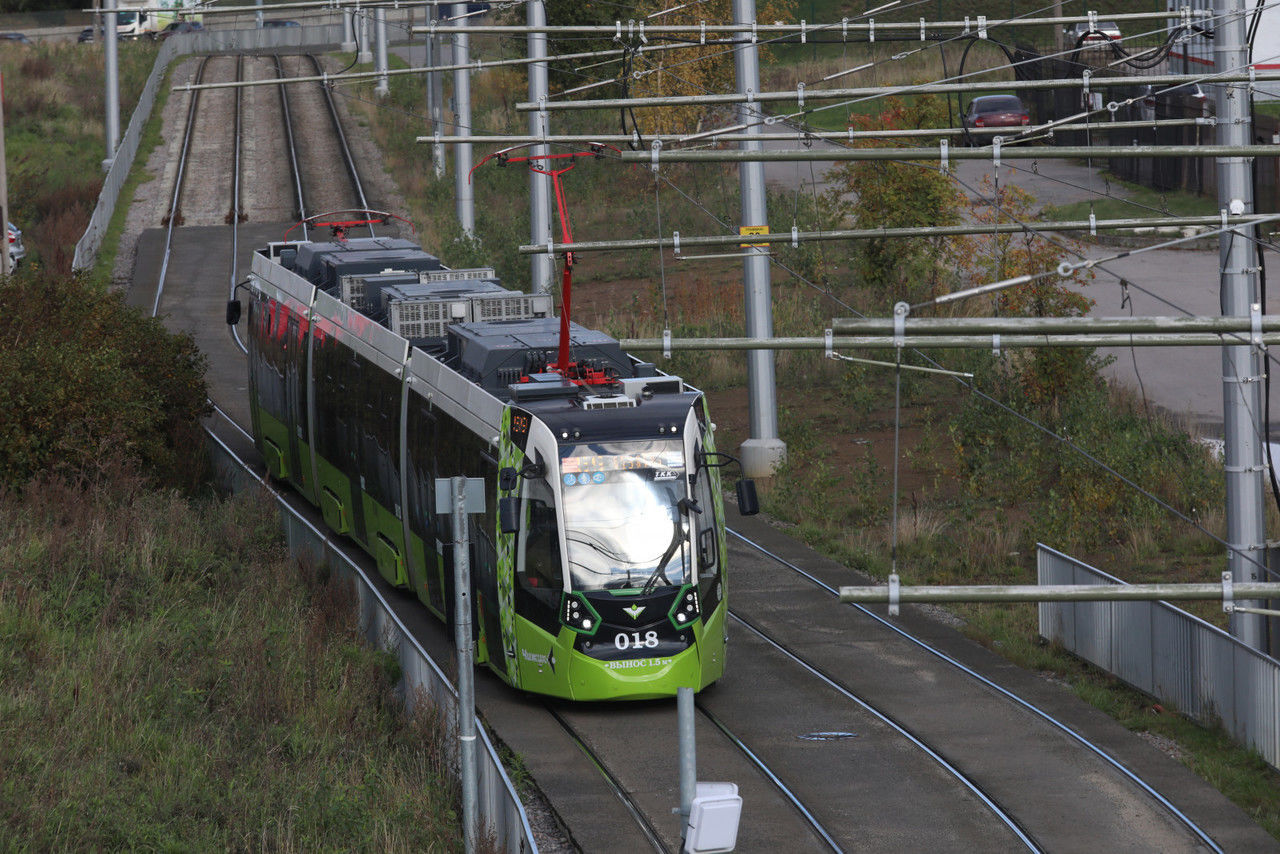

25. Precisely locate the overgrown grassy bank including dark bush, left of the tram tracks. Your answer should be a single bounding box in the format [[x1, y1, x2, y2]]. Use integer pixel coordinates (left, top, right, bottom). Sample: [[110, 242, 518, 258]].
[[0, 45, 476, 851]]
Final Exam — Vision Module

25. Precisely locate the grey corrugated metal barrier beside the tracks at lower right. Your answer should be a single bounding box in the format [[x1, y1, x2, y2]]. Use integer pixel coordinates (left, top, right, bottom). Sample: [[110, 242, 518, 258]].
[[1036, 545, 1280, 768]]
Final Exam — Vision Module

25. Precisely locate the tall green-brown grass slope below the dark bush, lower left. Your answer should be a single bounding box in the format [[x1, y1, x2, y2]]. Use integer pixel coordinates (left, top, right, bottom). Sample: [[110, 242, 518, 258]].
[[0, 476, 473, 851]]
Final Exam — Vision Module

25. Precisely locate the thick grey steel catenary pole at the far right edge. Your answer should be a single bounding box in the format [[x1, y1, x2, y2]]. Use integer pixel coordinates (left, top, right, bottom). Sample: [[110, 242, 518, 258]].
[[1213, 0, 1266, 649]]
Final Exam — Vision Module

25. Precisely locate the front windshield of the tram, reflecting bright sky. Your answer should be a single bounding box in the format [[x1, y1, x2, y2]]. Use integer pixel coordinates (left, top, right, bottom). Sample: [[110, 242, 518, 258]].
[[561, 439, 695, 590]]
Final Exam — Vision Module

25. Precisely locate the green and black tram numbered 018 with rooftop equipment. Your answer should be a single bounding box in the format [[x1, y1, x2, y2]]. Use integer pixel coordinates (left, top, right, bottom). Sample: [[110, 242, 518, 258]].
[[228, 236, 755, 700]]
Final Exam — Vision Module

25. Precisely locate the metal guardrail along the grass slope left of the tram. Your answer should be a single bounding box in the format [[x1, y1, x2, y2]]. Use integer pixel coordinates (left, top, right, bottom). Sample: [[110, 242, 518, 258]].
[[209, 431, 538, 854]]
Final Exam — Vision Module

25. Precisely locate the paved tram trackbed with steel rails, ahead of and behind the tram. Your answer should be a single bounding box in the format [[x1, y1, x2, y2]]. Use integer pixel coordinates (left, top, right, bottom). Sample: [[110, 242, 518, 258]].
[[135, 45, 1274, 851]]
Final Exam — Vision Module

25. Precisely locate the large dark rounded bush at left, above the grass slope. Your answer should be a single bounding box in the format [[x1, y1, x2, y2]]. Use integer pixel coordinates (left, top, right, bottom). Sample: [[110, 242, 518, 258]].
[[0, 270, 209, 487]]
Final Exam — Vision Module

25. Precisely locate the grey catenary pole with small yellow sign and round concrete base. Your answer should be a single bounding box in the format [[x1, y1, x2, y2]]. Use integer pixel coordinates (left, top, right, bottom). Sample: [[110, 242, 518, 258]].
[[733, 0, 787, 478]]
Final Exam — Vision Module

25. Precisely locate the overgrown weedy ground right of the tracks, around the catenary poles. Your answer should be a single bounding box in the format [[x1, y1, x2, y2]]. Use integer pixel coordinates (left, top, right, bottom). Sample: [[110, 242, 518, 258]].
[[340, 23, 1280, 837]]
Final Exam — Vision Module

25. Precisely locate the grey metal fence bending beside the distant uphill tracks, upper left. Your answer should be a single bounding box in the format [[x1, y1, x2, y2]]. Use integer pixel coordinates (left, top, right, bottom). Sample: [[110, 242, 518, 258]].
[[72, 23, 342, 270]]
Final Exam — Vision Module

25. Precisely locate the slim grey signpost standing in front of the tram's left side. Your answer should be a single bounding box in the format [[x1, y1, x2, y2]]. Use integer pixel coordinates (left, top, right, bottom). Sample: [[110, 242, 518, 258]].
[[449, 478, 476, 854]]
